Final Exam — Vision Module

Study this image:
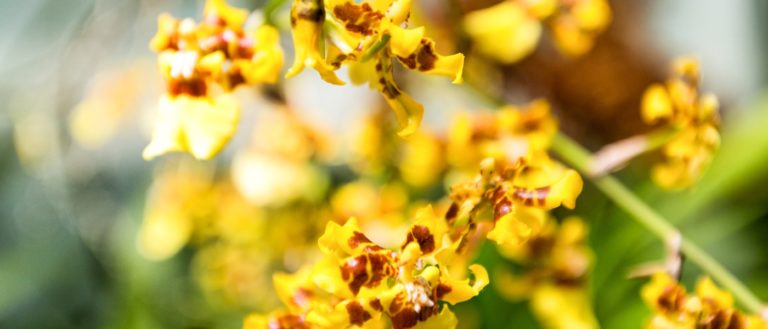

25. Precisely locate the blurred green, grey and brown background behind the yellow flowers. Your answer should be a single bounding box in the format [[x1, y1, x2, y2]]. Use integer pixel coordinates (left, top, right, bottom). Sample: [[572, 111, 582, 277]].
[[0, 0, 768, 328]]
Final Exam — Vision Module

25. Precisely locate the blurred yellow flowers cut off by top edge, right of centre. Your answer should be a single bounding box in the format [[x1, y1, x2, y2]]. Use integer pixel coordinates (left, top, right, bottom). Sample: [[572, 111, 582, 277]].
[[464, 0, 611, 64]]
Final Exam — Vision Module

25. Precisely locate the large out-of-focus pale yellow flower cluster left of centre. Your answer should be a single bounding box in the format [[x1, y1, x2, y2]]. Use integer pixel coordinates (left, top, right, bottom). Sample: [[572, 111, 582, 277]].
[[137, 109, 332, 309]]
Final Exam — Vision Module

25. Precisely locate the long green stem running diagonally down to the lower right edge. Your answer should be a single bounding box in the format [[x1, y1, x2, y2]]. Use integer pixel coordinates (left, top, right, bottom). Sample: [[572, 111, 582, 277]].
[[552, 134, 765, 314]]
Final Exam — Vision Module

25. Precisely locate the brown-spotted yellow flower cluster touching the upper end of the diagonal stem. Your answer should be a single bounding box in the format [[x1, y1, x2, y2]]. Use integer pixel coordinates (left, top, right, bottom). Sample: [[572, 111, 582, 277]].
[[446, 101, 583, 245]]
